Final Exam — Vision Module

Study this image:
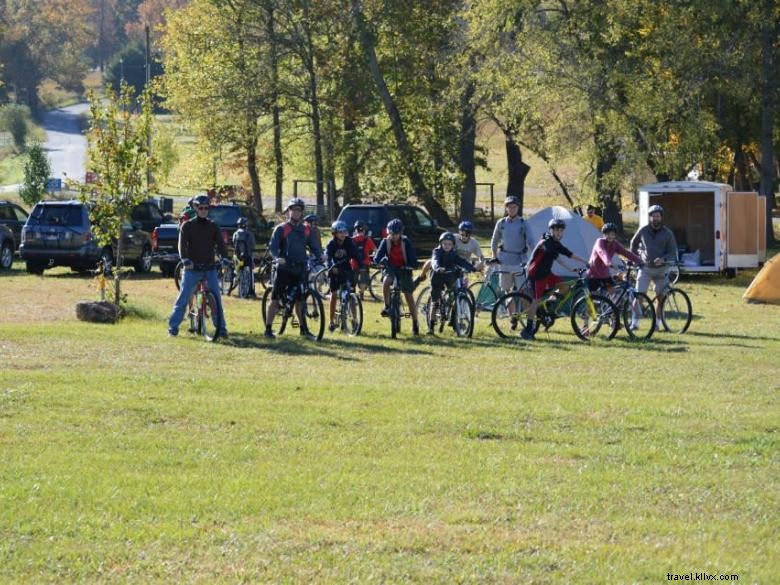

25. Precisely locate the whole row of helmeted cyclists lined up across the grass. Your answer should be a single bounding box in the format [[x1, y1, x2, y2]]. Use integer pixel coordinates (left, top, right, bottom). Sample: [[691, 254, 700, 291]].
[[168, 189, 677, 340]]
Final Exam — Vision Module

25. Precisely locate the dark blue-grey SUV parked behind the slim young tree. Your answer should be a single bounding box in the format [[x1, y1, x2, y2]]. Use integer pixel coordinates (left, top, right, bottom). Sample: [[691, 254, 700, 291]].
[[19, 201, 152, 274]]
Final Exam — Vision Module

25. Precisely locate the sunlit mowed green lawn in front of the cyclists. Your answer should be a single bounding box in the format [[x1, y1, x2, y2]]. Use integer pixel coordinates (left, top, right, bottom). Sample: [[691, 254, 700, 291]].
[[0, 263, 780, 583]]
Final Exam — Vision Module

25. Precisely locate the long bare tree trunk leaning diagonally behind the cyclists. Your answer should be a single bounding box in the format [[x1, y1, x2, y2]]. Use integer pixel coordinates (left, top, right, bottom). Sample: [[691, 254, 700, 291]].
[[351, 0, 453, 226]]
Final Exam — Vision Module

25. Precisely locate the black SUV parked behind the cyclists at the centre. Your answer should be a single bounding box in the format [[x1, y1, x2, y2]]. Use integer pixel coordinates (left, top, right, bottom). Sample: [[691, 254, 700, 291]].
[[338, 203, 445, 257]]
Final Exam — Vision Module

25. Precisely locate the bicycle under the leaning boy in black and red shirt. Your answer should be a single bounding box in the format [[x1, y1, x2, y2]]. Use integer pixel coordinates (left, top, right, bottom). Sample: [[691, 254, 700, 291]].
[[491, 268, 620, 341]]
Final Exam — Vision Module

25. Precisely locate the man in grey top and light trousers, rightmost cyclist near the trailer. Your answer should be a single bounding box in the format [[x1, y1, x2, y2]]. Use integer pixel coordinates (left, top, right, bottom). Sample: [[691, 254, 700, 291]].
[[630, 205, 677, 328]]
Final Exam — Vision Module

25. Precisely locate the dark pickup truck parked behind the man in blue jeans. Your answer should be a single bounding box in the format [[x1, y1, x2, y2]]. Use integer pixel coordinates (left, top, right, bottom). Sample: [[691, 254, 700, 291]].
[[152, 203, 274, 276]]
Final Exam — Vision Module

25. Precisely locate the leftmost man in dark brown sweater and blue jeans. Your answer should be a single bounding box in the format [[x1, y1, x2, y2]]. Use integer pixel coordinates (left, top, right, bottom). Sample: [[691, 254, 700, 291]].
[[168, 195, 228, 337]]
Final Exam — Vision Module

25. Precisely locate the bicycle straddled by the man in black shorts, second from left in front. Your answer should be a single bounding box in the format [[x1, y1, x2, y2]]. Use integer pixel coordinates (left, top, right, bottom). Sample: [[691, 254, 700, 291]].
[[261, 265, 325, 341]]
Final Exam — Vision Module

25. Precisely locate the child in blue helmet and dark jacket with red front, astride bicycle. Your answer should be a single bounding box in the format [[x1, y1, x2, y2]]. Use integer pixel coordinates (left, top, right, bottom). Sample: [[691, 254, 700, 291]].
[[374, 219, 420, 335]]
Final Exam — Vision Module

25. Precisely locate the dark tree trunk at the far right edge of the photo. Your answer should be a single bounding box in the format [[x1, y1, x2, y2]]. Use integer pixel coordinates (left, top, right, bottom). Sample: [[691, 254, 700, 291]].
[[759, 0, 777, 246]]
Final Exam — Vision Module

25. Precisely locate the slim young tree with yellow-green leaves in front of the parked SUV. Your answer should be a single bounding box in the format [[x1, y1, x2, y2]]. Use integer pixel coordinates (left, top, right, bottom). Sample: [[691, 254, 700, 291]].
[[80, 85, 155, 305]]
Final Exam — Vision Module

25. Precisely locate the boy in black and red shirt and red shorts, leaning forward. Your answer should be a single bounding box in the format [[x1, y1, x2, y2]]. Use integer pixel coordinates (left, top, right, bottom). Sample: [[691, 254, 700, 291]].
[[521, 218, 588, 340]]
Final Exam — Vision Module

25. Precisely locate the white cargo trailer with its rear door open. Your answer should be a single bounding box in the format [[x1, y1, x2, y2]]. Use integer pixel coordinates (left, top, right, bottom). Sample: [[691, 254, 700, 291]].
[[639, 181, 766, 275]]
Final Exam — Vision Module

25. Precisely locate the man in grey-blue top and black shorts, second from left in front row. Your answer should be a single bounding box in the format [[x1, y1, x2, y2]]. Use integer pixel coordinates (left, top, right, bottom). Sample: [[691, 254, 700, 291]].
[[265, 197, 322, 339]]
